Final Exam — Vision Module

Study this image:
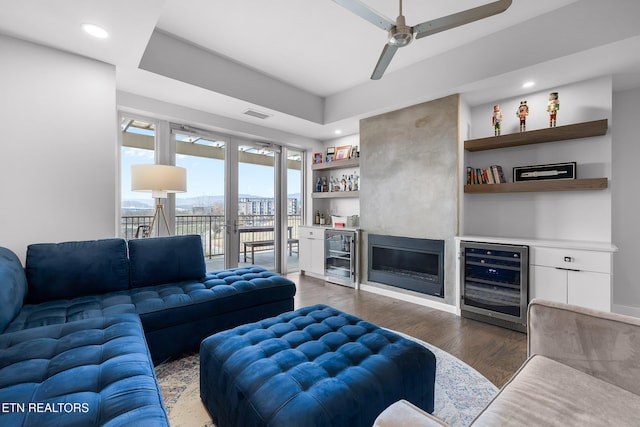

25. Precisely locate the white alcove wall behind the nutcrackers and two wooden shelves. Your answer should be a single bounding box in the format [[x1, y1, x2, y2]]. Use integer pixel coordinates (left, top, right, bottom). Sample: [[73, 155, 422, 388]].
[[461, 77, 615, 243]]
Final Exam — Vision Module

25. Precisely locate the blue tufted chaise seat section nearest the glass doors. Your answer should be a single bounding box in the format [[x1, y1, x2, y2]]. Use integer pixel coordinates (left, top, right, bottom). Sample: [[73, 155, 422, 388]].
[[134, 266, 296, 362]]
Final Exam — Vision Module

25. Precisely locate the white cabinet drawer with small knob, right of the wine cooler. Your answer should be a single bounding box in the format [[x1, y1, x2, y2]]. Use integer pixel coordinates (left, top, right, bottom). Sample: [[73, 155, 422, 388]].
[[529, 247, 611, 273]]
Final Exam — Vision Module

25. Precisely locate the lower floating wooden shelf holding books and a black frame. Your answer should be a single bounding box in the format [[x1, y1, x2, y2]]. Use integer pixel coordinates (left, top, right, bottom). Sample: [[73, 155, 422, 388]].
[[464, 178, 609, 194]]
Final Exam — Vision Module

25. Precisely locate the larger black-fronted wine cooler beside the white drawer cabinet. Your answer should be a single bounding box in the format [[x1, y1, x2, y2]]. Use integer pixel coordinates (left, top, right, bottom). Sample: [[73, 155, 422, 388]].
[[460, 241, 529, 332]]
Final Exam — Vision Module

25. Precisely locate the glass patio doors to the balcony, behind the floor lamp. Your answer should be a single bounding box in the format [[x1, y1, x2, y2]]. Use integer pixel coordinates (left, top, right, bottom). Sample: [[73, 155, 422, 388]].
[[120, 113, 303, 272]]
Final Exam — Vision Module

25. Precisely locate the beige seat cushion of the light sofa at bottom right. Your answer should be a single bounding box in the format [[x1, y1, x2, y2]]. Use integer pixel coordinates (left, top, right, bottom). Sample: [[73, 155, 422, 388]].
[[472, 355, 640, 427]]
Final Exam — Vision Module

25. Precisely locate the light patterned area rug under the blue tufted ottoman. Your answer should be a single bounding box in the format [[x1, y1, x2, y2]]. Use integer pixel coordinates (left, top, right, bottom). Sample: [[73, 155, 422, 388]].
[[156, 332, 498, 427]]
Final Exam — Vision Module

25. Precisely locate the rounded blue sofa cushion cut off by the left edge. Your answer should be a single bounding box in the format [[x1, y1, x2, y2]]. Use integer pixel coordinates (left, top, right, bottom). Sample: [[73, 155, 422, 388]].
[[0, 248, 27, 332]]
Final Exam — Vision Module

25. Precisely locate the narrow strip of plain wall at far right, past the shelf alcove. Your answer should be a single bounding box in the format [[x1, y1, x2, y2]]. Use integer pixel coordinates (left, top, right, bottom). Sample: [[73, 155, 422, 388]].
[[612, 88, 640, 317]]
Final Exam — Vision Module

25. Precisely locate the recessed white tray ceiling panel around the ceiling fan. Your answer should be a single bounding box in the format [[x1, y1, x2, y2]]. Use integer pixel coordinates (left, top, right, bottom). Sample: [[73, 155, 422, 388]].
[[158, 0, 575, 96]]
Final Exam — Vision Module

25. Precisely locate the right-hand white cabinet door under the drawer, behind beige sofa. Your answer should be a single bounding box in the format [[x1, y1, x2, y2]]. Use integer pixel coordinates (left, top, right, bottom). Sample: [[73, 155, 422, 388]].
[[567, 271, 611, 311]]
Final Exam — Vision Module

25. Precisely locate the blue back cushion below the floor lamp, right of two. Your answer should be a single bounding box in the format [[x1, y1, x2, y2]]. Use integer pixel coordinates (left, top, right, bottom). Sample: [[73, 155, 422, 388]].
[[129, 235, 206, 288]]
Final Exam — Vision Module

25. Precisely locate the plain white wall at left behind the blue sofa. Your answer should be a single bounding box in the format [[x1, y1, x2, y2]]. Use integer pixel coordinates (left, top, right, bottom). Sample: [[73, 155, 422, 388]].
[[0, 36, 117, 260]]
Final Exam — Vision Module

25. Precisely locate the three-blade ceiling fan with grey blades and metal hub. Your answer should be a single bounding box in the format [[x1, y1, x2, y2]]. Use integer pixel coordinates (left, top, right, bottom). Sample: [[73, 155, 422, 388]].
[[333, 0, 512, 80]]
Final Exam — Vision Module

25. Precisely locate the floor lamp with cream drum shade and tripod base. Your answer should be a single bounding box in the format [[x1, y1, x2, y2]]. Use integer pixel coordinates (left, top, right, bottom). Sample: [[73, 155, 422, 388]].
[[131, 165, 187, 235]]
